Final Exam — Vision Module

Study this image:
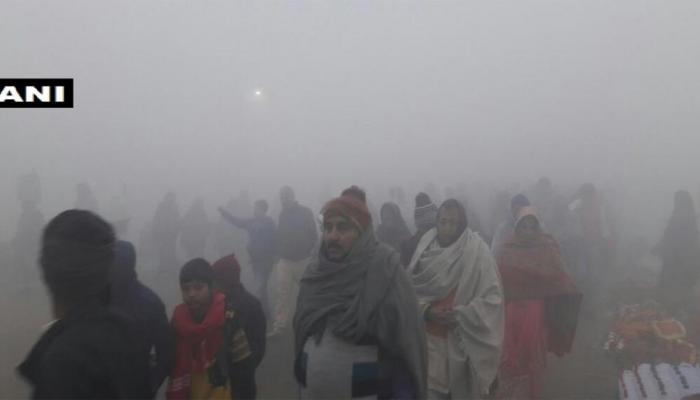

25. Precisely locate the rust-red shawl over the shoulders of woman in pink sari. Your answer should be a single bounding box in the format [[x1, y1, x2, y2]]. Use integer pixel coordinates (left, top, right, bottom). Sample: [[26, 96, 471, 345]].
[[497, 233, 582, 355]]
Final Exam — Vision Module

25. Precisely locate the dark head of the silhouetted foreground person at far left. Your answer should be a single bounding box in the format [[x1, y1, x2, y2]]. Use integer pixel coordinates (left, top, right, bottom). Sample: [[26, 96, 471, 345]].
[[39, 210, 115, 305]]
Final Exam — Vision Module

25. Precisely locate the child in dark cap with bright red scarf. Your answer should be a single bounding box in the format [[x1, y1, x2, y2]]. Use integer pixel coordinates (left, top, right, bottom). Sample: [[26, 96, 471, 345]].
[[167, 258, 231, 399]]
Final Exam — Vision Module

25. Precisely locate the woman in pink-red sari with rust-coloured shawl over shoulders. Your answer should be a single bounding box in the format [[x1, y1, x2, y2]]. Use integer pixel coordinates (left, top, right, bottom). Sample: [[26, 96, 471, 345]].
[[496, 207, 582, 399]]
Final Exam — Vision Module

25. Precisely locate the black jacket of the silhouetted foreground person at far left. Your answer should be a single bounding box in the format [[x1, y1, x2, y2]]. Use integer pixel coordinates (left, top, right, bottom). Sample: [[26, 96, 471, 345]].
[[18, 300, 151, 399]]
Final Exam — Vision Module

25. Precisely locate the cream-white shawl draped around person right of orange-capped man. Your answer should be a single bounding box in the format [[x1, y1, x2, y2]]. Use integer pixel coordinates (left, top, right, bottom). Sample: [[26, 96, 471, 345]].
[[408, 228, 505, 399]]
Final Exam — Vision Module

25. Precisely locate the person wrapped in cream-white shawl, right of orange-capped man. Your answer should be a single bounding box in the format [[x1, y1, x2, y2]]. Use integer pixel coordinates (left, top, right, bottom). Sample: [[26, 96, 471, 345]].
[[408, 199, 504, 399]]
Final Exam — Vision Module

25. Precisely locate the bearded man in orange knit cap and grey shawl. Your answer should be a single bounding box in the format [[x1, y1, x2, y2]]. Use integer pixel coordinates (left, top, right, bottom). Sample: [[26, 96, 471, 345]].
[[294, 187, 427, 399]]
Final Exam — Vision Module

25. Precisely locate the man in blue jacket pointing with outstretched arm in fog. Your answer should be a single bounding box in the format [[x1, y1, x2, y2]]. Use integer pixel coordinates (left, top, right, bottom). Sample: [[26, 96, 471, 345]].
[[219, 200, 277, 316]]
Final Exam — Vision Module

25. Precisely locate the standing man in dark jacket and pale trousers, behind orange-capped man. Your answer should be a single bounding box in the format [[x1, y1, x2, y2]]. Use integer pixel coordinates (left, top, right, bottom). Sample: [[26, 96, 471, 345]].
[[270, 186, 318, 336]]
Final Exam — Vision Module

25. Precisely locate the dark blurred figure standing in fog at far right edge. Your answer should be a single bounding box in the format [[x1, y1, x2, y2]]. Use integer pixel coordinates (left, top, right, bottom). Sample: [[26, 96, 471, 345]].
[[654, 190, 700, 309]]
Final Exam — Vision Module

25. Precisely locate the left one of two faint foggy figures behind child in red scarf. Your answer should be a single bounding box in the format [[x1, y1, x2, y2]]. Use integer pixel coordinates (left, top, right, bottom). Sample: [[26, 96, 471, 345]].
[[151, 193, 180, 274]]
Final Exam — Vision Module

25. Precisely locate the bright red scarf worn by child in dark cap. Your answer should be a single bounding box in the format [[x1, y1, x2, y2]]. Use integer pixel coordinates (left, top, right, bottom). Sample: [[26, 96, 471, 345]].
[[166, 292, 225, 400]]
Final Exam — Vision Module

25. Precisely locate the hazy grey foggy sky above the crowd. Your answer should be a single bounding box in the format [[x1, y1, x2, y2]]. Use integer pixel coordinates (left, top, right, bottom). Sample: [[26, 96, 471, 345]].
[[0, 0, 700, 239]]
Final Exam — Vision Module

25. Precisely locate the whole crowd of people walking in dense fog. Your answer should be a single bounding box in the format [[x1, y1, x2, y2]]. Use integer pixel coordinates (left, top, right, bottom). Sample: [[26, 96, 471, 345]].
[[6, 176, 700, 399]]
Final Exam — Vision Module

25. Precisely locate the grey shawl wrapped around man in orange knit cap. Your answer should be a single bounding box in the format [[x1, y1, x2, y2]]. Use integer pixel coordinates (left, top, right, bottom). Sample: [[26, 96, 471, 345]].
[[294, 229, 427, 399]]
